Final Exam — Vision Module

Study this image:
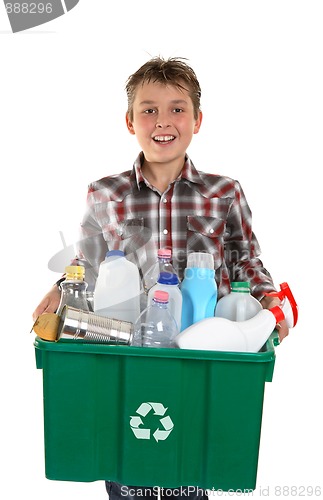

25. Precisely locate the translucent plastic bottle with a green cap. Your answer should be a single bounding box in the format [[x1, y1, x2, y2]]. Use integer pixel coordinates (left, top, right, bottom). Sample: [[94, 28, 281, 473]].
[[214, 281, 262, 321]]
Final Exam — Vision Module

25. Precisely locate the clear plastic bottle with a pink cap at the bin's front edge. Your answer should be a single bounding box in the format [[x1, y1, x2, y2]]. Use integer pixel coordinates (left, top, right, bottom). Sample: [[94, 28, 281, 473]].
[[133, 290, 178, 347]]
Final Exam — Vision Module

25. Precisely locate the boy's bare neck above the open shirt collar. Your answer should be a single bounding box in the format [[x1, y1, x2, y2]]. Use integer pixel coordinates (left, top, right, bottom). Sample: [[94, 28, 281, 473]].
[[141, 158, 185, 193]]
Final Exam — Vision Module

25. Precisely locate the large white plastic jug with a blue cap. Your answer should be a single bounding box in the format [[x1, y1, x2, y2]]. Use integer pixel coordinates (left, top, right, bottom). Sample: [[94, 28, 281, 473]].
[[93, 250, 140, 323]]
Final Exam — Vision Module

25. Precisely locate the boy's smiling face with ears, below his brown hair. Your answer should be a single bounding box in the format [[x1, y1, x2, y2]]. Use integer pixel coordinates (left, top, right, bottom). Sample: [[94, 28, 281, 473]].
[[126, 82, 202, 168]]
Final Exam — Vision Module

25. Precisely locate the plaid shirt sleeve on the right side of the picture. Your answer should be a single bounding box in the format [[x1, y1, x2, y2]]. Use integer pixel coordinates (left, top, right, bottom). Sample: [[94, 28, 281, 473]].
[[224, 181, 275, 300]]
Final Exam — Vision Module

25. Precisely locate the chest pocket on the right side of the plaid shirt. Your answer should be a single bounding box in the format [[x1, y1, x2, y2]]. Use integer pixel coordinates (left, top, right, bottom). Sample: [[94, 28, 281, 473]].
[[187, 215, 226, 269]]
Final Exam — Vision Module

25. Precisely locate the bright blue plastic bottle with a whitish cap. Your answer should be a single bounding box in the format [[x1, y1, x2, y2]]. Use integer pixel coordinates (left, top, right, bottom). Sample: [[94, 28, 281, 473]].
[[181, 252, 217, 330]]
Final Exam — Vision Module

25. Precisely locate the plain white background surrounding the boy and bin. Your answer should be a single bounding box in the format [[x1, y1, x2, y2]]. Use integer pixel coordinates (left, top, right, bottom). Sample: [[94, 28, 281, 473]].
[[0, 0, 323, 500]]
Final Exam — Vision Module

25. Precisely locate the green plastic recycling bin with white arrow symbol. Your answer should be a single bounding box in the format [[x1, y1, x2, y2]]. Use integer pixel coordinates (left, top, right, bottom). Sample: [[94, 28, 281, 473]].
[[34, 334, 277, 491]]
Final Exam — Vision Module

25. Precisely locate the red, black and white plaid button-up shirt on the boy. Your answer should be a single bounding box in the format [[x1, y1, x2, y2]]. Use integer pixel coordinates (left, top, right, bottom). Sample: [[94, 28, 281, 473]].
[[79, 153, 275, 299]]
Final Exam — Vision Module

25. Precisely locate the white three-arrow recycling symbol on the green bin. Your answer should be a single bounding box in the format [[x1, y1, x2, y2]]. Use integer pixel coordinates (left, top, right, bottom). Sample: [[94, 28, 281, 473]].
[[130, 403, 174, 442]]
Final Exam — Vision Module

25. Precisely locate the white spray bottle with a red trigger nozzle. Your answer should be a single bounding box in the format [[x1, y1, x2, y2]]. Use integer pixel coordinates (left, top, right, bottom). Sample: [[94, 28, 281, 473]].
[[175, 283, 298, 352]]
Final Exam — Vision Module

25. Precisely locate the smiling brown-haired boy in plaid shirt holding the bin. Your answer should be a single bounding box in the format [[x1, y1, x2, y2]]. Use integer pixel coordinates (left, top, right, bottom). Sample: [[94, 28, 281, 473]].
[[33, 57, 288, 498]]
